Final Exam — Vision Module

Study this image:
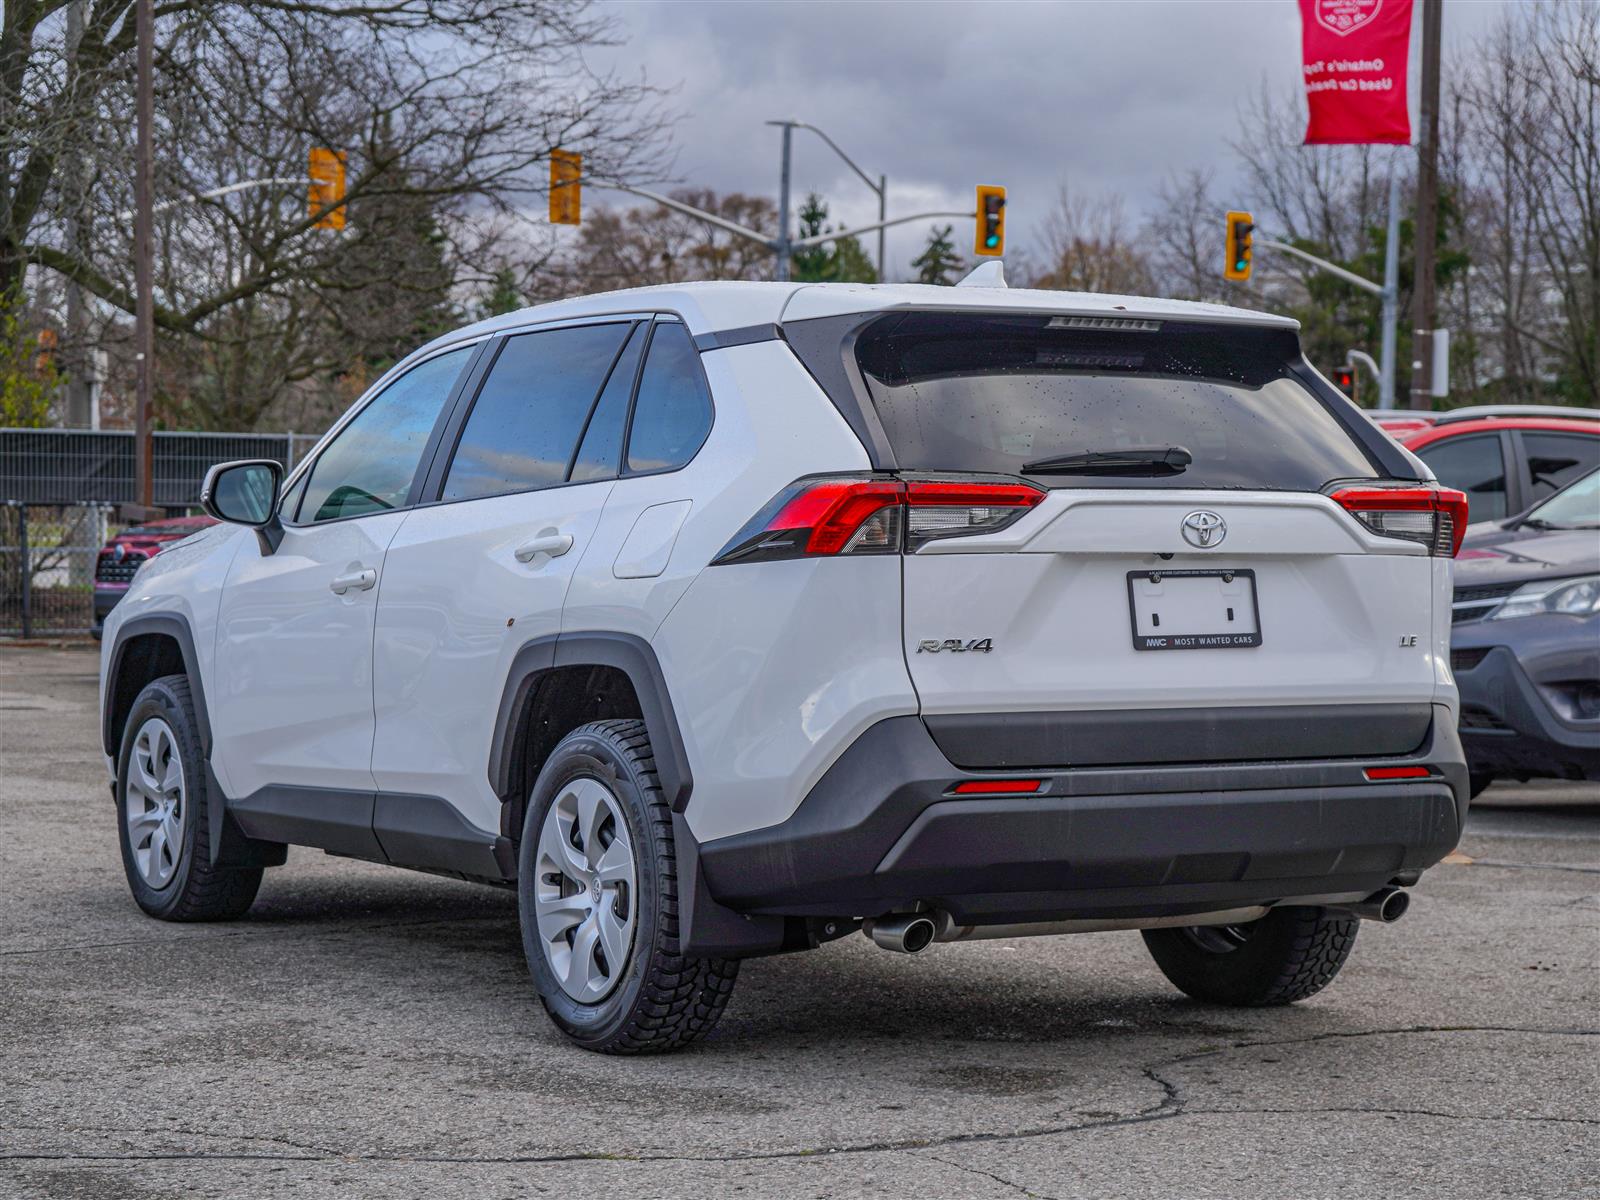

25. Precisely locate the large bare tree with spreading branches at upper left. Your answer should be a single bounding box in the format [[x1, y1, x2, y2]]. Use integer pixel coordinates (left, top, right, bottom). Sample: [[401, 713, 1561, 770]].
[[0, 0, 666, 427]]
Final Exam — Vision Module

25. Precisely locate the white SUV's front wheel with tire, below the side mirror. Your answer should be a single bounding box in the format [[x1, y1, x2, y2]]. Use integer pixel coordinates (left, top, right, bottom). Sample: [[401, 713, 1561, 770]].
[[115, 675, 261, 922]]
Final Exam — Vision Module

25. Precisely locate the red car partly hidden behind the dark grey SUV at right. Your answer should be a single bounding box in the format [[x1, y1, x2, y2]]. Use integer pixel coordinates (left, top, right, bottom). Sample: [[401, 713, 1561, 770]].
[[1397, 408, 1600, 522]]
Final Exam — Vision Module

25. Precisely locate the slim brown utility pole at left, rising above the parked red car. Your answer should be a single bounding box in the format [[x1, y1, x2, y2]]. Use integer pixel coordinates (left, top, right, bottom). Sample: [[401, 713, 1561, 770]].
[[133, 0, 155, 520]]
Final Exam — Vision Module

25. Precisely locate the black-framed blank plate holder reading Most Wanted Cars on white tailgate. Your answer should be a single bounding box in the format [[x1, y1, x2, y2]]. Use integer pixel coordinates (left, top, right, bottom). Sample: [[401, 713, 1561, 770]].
[[1128, 566, 1261, 650]]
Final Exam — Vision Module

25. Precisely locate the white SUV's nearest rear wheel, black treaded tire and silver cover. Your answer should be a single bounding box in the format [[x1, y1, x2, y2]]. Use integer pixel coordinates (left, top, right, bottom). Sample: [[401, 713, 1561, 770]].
[[517, 720, 739, 1054]]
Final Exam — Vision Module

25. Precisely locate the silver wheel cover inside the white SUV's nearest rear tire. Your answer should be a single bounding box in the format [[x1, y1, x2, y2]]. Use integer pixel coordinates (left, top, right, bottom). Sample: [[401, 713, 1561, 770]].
[[533, 776, 638, 1005]]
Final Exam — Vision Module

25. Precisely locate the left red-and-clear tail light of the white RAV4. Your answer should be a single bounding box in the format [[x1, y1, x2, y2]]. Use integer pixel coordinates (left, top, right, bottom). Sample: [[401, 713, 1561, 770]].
[[712, 475, 1045, 563]]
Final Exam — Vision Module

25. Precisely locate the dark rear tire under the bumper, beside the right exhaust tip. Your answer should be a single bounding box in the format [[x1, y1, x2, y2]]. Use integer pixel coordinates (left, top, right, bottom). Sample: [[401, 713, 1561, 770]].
[[1144, 907, 1362, 1008]]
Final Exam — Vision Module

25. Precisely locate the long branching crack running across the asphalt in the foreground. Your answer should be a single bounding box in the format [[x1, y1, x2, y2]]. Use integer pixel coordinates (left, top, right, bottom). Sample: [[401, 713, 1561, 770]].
[[0, 1026, 1600, 1171]]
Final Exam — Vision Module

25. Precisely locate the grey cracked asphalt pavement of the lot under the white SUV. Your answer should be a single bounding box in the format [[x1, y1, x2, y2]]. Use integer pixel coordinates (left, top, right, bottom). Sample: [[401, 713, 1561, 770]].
[[0, 648, 1600, 1200]]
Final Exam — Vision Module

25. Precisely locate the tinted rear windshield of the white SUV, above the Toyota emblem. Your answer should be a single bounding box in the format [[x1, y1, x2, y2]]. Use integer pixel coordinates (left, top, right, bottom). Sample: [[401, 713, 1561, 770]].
[[856, 312, 1379, 491]]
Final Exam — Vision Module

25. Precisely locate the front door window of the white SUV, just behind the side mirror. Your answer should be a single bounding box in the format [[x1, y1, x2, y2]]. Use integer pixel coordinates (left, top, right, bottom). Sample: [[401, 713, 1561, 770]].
[[299, 346, 474, 523]]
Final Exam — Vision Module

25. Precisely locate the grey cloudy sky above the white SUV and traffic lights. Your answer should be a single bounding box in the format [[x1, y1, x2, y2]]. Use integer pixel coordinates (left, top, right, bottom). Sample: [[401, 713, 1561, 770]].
[[603, 0, 1518, 277]]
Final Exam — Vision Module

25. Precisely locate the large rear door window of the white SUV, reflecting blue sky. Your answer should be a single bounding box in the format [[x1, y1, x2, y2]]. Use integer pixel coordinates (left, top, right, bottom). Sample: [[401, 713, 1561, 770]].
[[443, 323, 630, 501]]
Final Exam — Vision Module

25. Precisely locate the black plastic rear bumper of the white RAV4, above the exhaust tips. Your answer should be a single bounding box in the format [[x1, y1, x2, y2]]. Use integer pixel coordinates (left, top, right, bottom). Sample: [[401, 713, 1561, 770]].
[[699, 706, 1467, 925]]
